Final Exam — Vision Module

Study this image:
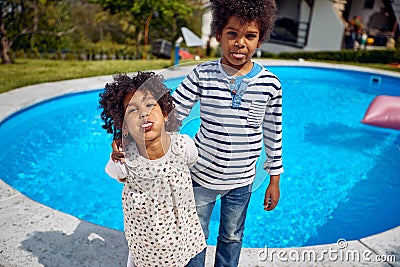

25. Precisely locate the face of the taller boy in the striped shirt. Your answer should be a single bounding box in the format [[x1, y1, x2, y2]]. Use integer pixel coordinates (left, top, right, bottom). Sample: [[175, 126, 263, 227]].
[[216, 16, 261, 74]]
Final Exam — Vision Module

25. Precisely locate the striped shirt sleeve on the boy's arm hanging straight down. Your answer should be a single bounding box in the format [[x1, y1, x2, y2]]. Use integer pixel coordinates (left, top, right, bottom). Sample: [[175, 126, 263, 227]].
[[263, 80, 283, 175]]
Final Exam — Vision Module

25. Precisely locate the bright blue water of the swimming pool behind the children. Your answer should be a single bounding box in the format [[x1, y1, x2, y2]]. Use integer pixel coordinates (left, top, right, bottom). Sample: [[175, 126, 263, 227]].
[[0, 67, 400, 247]]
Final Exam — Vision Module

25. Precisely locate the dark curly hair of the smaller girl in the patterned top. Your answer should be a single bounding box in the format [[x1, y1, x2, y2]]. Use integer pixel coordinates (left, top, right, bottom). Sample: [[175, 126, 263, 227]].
[[99, 72, 181, 139]]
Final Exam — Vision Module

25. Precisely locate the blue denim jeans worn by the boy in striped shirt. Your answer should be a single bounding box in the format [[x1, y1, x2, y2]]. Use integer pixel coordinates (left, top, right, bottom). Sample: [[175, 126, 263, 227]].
[[187, 181, 252, 267]]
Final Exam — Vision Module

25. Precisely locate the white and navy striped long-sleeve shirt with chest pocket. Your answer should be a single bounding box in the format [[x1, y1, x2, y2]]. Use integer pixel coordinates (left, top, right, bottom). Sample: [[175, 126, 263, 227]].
[[173, 60, 283, 190]]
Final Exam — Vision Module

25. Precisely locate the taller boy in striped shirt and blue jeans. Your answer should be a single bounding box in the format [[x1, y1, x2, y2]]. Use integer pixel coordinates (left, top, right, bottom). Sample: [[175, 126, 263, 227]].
[[173, 0, 283, 266]]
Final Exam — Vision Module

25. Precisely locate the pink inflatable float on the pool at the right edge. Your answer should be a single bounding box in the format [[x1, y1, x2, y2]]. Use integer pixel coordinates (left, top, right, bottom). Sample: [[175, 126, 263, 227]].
[[361, 95, 400, 130]]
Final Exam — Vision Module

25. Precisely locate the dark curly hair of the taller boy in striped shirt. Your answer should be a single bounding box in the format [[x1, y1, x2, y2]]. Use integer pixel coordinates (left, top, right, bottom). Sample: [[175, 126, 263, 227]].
[[211, 0, 278, 41]]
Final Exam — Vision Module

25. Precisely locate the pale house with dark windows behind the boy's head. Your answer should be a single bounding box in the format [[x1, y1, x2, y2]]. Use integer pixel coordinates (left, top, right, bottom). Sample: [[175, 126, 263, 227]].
[[202, 0, 400, 53]]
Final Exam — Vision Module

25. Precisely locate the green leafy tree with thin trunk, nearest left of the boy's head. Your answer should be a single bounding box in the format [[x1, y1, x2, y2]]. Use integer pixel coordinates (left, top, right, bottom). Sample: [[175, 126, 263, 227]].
[[92, 0, 193, 58]]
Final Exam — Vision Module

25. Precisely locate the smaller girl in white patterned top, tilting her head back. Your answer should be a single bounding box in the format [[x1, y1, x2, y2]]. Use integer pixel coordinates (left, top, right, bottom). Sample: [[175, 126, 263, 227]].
[[100, 72, 206, 266]]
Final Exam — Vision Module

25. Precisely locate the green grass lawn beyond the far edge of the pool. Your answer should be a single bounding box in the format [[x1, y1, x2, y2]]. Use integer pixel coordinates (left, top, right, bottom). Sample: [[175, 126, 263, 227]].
[[0, 59, 400, 93]]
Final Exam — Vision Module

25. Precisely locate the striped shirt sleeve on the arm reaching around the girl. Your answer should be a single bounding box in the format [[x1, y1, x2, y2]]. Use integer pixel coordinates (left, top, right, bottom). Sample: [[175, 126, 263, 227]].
[[172, 68, 201, 121]]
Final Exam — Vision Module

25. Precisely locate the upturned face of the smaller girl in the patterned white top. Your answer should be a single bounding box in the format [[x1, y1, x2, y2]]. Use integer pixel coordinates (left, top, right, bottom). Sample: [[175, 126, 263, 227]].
[[124, 90, 167, 144]]
